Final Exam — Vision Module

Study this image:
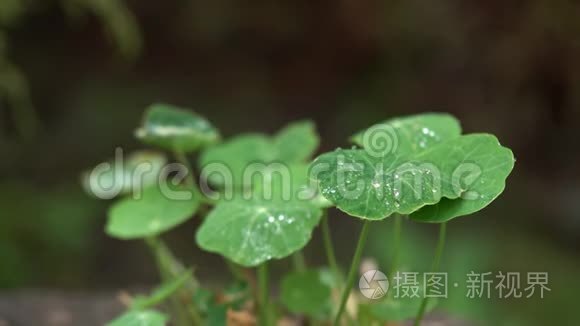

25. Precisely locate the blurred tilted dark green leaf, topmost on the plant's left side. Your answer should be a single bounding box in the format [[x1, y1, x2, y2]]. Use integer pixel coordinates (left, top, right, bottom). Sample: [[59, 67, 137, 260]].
[[135, 104, 220, 153]]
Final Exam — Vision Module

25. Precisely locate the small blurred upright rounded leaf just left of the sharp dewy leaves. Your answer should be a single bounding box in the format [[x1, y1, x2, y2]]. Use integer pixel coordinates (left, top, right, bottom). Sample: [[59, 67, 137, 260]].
[[273, 121, 320, 162]]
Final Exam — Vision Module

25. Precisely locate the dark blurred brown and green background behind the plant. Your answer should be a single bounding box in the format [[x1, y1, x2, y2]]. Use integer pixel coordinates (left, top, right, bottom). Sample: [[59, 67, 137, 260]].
[[0, 0, 580, 325]]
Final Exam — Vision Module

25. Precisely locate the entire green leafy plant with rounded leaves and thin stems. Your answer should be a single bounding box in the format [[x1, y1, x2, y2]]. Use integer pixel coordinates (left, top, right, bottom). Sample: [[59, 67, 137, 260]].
[[84, 104, 514, 325]]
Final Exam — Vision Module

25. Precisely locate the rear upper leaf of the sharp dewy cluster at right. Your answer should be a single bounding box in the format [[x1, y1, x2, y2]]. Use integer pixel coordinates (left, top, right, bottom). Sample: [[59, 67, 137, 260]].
[[351, 113, 461, 156]]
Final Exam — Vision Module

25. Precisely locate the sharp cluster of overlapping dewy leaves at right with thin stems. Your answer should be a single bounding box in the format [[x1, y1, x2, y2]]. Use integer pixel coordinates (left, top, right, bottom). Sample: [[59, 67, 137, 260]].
[[311, 113, 515, 324]]
